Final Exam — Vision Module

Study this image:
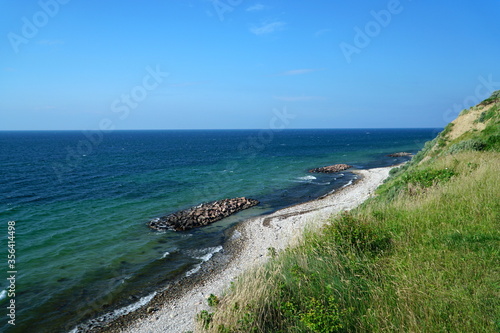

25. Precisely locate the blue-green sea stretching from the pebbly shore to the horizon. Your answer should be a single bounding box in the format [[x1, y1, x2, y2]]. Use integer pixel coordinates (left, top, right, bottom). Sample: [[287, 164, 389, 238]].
[[0, 129, 439, 332]]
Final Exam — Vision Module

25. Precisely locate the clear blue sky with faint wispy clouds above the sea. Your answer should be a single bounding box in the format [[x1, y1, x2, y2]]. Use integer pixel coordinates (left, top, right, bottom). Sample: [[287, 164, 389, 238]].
[[0, 0, 500, 131]]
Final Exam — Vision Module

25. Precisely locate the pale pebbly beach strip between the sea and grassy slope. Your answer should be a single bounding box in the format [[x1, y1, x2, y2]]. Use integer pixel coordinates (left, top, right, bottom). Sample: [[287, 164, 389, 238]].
[[105, 167, 392, 333]]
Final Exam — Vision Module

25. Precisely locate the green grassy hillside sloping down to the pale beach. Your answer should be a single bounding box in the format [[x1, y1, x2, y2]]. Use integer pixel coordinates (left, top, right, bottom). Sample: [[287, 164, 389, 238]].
[[199, 92, 500, 332]]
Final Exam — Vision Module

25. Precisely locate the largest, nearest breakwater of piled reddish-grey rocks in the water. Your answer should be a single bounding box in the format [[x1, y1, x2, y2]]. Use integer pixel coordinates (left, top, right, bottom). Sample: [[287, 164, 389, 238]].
[[149, 197, 259, 231]]
